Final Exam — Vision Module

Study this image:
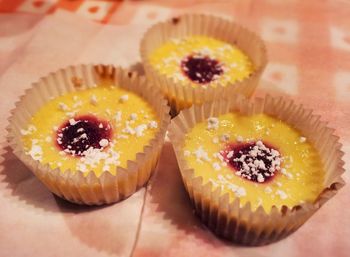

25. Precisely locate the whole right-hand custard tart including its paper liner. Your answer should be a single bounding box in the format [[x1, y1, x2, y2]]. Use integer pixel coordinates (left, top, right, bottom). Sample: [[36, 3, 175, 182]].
[[169, 96, 344, 245]]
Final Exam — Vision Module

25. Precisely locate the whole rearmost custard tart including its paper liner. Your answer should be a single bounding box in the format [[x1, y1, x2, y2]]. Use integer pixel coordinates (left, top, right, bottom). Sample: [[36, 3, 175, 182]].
[[141, 15, 267, 113]]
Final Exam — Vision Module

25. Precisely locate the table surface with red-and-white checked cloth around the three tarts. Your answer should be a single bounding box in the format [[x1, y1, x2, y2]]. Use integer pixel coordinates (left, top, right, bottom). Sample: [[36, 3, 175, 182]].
[[0, 0, 350, 257]]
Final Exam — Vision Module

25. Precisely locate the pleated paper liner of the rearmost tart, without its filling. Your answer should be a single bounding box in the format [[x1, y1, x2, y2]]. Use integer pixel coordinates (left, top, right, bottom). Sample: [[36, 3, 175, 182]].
[[140, 14, 267, 112]]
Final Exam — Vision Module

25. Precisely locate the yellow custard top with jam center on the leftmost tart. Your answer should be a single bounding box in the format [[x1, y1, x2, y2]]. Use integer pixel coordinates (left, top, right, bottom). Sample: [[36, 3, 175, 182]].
[[21, 86, 159, 176]]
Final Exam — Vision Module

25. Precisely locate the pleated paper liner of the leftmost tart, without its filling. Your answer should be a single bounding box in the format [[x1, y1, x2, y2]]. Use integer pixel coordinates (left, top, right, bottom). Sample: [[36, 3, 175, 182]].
[[8, 65, 170, 205]]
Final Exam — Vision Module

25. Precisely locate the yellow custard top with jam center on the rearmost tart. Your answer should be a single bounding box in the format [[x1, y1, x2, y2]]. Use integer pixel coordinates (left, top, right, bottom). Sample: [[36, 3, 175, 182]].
[[149, 36, 254, 86]]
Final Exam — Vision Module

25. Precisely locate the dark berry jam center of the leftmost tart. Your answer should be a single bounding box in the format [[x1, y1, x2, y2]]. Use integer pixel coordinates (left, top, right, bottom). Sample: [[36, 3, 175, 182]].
[[56, 115, 112, 156]]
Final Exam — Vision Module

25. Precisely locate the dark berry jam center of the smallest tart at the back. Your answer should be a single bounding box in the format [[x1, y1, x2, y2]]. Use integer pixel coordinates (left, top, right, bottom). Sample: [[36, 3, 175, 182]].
[[181, 54, 224, 84]]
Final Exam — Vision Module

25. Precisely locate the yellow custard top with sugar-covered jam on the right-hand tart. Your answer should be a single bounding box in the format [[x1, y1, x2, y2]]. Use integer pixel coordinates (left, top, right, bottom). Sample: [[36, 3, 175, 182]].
[[183, 113, 324, 212]]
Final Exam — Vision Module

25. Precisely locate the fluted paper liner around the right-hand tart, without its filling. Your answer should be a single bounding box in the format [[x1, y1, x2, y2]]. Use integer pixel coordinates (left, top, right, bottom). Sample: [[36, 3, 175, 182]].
[[169, 93, 345, 246]]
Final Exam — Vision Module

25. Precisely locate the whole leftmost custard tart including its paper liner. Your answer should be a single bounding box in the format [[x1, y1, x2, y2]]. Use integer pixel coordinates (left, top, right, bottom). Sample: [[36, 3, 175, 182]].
[[9, 65, 170, 205]]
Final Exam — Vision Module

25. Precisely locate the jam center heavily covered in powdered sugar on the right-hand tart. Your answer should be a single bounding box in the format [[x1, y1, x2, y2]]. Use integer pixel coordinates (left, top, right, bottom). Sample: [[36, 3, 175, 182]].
[[222, 141, 283, 183]]
